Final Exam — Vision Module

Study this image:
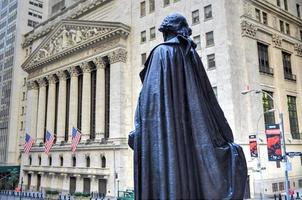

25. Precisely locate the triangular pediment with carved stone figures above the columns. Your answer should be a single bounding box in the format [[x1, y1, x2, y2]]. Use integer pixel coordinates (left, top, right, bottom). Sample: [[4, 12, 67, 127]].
[[22, 20, 130, 71]]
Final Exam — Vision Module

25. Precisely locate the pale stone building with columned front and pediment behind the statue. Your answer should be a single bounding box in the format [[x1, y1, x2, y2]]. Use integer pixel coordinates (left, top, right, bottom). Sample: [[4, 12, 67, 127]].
[[21, 0, 302, 196]]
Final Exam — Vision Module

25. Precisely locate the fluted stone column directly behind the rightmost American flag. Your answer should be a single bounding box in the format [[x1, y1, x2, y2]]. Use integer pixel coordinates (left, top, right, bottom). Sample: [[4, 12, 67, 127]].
[[68, 67, 79, 142]]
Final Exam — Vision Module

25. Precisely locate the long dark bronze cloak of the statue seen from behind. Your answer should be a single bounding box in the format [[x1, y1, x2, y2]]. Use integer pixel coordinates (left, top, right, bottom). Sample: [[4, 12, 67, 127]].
[[129, 36, 247, 199]]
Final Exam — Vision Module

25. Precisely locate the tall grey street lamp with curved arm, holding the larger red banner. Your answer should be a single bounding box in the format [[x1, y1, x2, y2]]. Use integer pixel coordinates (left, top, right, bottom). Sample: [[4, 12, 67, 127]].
[[241, 89, 289, 199]]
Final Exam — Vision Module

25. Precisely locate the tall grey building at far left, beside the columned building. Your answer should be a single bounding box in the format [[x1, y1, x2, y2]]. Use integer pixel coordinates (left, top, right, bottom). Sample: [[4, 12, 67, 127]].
[[0, 0, 45, 170]]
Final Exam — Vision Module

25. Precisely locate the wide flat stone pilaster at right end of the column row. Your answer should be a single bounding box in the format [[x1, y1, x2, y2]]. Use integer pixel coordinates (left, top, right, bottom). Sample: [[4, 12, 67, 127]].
[[108, 49, 133, 141]]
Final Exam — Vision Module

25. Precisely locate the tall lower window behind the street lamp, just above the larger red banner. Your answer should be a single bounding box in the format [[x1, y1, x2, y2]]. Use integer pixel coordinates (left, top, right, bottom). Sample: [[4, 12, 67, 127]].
[[262, 91, 275, 125]]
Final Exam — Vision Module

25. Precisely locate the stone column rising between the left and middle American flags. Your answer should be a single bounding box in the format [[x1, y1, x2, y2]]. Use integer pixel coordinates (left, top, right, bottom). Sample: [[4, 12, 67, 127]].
[[36, 78, 47, 144]]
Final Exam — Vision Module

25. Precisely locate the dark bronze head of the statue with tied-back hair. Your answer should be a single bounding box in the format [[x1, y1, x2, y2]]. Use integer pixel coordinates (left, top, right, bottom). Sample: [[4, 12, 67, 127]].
[[158, 13, 192, 41]]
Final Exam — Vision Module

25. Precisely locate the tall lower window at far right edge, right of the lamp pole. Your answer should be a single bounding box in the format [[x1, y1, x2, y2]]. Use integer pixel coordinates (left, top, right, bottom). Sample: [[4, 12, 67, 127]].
[[287, 95, 301, 139]]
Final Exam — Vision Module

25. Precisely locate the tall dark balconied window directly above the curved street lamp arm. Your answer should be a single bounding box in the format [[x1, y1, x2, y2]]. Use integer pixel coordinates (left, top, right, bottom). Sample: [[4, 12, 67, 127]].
[[257, 42, 273, 75]]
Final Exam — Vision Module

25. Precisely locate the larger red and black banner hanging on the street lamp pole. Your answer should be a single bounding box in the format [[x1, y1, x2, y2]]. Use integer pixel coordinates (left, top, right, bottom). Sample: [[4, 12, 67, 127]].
[[265, 124, 282, 161]]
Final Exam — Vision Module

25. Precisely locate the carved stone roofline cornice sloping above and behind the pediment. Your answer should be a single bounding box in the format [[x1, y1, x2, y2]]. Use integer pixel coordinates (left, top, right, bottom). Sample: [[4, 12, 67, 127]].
[[23, 0, 112, 47]]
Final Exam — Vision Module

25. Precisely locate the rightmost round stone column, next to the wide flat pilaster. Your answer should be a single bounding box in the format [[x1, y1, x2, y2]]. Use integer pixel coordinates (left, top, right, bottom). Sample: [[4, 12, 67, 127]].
[[93, 57, 106, 141]]
